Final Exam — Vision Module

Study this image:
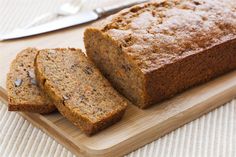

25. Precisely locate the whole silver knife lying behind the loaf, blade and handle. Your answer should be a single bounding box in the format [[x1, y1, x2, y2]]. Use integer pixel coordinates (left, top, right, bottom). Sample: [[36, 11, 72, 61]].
[[0, 0, 148, 41]]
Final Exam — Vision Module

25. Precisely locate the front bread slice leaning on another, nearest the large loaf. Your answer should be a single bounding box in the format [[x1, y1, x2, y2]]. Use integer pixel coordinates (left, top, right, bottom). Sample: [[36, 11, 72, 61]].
[[35, 49, 127, 135]]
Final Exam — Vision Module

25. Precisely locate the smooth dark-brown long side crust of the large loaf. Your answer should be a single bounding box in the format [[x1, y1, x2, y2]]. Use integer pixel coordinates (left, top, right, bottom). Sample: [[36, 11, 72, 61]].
[[144, 39, 236, 108]]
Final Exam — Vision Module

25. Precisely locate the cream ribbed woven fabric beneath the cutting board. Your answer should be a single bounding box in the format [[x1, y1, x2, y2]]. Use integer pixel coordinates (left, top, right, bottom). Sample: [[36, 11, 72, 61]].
[[0, 0, 236, 157]]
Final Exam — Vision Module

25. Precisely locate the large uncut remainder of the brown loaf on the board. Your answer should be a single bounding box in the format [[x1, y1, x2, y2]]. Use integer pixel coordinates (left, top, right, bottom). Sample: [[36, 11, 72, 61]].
[[84, 0, 236, 108]]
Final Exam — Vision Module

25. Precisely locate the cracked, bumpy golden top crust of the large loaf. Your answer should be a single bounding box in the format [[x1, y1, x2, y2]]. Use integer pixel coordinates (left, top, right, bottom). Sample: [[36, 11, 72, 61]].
[[94, 0, 236, 73]]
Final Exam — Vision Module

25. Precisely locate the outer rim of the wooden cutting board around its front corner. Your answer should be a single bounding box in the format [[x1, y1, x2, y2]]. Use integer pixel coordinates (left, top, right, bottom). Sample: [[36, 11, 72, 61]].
[[0, 72, 236, 157]]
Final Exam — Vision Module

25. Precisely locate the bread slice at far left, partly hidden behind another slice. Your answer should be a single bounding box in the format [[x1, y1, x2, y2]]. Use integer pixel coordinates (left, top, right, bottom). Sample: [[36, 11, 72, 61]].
[[7, 48, 56, 113]]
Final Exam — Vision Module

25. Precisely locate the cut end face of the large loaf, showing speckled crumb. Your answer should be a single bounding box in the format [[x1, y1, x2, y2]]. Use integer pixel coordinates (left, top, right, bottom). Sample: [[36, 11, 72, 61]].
[[84, 28, 146, 108]]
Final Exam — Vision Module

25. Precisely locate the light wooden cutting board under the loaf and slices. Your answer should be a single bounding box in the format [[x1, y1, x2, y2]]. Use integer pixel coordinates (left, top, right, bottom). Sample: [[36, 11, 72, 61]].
[[0, 25, 236, 157]]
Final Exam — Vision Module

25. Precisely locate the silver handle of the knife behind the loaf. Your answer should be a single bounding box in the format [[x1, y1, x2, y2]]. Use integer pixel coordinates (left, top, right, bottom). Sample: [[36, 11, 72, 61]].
[[94, 0, 149, 17]]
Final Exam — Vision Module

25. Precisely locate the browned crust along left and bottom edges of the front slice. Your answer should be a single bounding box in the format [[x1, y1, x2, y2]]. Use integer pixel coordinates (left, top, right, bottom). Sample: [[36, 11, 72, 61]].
[[35, 49, 126, 136]]
